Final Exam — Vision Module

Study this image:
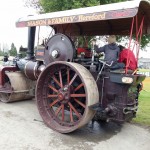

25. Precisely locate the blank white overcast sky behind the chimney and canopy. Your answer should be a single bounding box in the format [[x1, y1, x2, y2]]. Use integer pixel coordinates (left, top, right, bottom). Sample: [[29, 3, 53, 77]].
[[0, 0, 150, 58]]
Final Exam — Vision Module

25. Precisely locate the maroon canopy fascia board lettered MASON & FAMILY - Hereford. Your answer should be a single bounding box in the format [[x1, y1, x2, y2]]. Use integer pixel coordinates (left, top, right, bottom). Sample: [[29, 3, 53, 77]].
[[16, 8, 137, 27]]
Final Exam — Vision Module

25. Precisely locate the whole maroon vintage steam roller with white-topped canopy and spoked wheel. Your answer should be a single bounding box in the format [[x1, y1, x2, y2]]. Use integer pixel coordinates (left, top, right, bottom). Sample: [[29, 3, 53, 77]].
[[0, 0, 150, 133]]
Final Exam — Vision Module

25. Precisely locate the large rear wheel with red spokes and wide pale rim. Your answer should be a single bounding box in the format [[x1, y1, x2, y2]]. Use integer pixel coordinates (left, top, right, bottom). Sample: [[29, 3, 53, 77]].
[[36, 61, 99, 133]]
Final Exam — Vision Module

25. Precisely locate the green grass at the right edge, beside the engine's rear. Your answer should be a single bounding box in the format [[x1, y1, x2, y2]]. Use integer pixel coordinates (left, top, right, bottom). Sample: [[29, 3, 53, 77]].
[[133, 77, 150, 126]]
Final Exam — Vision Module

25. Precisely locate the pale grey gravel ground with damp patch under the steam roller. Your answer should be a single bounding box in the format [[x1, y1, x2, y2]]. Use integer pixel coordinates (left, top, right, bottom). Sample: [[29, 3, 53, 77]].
[[0, 100, 150, 150]]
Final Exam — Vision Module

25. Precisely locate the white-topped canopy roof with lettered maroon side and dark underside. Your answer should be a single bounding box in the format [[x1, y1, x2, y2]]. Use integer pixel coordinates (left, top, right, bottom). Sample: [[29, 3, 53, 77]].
[[16, 0, 150, 35]]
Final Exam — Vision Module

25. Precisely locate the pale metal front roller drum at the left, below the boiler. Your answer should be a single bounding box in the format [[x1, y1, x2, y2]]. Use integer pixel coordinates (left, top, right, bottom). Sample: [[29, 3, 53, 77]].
[[0, 71, 34, 103]]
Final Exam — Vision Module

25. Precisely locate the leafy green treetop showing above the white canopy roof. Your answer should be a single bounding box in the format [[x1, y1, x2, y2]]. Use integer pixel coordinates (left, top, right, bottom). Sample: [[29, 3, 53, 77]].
[[26, 0, 126, 13]]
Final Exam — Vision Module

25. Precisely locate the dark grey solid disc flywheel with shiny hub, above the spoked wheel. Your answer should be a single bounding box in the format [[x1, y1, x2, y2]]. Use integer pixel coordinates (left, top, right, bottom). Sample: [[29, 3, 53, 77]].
[[44, 34, 75, 65]]
